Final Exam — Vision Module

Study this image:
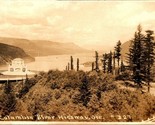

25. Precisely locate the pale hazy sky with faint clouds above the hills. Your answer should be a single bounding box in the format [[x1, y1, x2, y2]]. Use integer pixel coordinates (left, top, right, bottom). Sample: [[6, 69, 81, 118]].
[[0, 0, 155, 49]]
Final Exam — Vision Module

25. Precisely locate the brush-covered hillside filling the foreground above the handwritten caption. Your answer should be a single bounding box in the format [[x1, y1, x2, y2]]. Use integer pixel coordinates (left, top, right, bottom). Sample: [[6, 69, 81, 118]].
[[0, 70, 155, 121]]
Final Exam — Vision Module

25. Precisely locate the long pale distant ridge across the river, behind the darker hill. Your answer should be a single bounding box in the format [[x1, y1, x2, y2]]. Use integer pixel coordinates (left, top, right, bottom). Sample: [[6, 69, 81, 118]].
[[0, 37, 90, 56]]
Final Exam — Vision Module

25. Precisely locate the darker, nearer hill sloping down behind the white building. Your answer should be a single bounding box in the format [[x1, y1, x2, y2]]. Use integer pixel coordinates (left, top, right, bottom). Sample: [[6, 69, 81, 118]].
[[0, 43, 34, 65]]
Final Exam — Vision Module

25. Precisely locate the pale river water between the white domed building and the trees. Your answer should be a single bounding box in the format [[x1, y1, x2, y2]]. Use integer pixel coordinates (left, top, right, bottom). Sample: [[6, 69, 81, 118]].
[[27, 53, 95, 71]]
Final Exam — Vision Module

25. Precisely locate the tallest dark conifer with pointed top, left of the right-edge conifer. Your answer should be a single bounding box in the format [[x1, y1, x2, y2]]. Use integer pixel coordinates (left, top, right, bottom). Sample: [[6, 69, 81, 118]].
[[128, 25, 145, 88]]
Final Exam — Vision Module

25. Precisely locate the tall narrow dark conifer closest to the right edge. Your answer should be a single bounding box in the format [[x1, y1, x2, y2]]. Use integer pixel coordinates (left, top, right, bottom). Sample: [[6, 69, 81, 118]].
[[144, 30, 155, 92]]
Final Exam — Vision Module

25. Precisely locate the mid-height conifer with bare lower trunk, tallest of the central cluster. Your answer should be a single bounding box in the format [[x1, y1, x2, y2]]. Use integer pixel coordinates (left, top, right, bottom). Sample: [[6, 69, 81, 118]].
[[115, 40, 121, 75]]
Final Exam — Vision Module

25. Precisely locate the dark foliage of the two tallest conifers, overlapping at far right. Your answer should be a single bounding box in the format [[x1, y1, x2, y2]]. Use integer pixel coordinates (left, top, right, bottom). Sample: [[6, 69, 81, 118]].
[[128, 25, 154, 90]]
